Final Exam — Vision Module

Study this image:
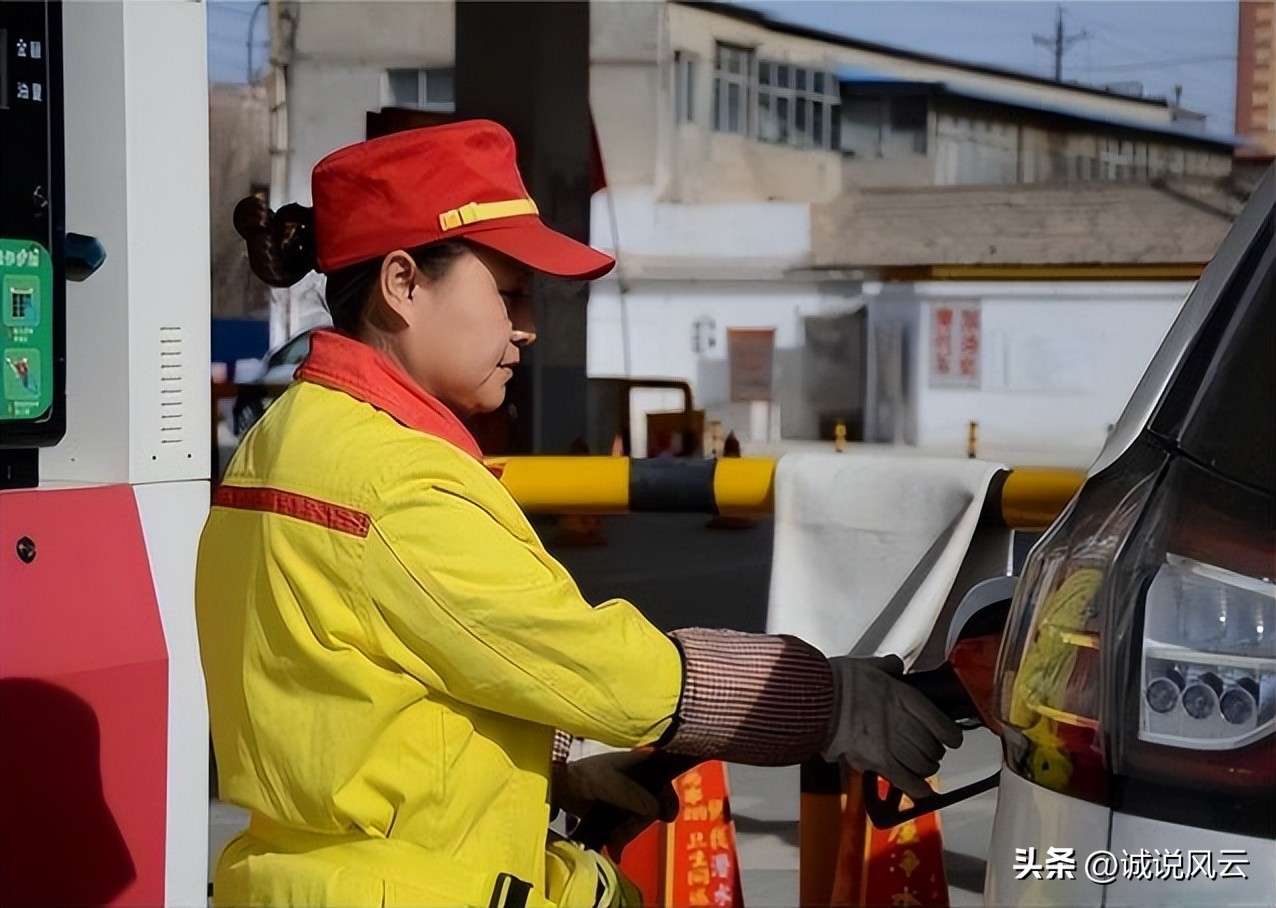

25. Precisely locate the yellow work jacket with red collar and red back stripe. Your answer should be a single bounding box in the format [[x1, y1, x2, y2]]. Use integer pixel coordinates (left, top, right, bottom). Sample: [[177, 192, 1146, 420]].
[[195, 332, 683, 908]]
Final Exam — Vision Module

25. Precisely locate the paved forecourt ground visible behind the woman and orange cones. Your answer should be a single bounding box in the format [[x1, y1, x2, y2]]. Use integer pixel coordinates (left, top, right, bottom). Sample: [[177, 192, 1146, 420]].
[[209, 515, 999, 908]]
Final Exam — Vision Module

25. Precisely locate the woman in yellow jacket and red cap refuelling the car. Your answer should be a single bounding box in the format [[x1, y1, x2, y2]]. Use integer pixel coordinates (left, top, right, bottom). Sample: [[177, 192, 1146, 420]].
[[197, 121, 961, 907]]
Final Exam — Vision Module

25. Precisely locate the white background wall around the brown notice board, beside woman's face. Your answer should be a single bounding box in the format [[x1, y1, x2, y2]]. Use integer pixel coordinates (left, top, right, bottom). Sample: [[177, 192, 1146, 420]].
[[587, 186, 863, 450]]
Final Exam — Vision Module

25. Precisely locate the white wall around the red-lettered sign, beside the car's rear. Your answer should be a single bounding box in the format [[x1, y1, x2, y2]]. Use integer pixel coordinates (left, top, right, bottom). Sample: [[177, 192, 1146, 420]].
[[865, 282, 1192, 465]]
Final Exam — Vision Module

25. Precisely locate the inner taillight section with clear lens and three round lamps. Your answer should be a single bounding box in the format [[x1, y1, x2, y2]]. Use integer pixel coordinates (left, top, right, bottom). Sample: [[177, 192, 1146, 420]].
[[1104, 458, 1276, 837]]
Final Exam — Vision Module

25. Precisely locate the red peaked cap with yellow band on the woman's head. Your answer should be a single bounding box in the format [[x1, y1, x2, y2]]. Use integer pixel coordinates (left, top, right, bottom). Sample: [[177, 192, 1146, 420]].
[[310, 120, 615, 281]]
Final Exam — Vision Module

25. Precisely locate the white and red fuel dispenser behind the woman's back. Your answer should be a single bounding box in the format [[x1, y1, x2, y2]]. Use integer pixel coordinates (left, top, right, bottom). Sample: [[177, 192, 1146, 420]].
[[0, 0, 209, 905]]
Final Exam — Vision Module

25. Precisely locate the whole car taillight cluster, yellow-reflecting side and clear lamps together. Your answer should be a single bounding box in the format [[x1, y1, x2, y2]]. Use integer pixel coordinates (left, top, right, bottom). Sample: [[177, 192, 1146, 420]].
[[998, 428, 1276, 835]]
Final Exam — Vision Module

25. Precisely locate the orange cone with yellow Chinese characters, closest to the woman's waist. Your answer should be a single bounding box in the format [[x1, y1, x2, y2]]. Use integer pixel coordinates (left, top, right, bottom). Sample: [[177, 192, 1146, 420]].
[[620, 760, 744, 908]]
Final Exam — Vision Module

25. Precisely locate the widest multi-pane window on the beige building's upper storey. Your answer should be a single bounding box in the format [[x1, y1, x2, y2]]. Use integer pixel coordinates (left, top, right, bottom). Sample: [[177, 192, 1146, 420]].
[[758, 60, 840, 148]]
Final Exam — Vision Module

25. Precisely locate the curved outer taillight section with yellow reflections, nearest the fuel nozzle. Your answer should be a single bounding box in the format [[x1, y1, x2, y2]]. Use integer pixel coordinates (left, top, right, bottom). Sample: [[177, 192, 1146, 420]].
[[997, 443, 1166, 801]]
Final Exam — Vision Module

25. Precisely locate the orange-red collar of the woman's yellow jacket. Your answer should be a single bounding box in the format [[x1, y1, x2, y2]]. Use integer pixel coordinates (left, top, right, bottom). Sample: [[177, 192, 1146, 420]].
[[297, 330, 482, 462]]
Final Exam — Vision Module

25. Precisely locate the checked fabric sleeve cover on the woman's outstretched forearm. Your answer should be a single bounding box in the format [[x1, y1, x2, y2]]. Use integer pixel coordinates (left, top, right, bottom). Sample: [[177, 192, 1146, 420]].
[[665, 627, 833, 766]]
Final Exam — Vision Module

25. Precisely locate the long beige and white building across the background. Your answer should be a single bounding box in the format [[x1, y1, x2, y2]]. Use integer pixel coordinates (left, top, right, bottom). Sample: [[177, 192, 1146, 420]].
[[266, 0, 1230, 460]]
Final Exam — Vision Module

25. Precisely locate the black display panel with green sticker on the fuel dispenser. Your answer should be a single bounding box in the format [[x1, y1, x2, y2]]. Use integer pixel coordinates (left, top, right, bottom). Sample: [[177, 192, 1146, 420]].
[[0, 0, 66, 438]]
